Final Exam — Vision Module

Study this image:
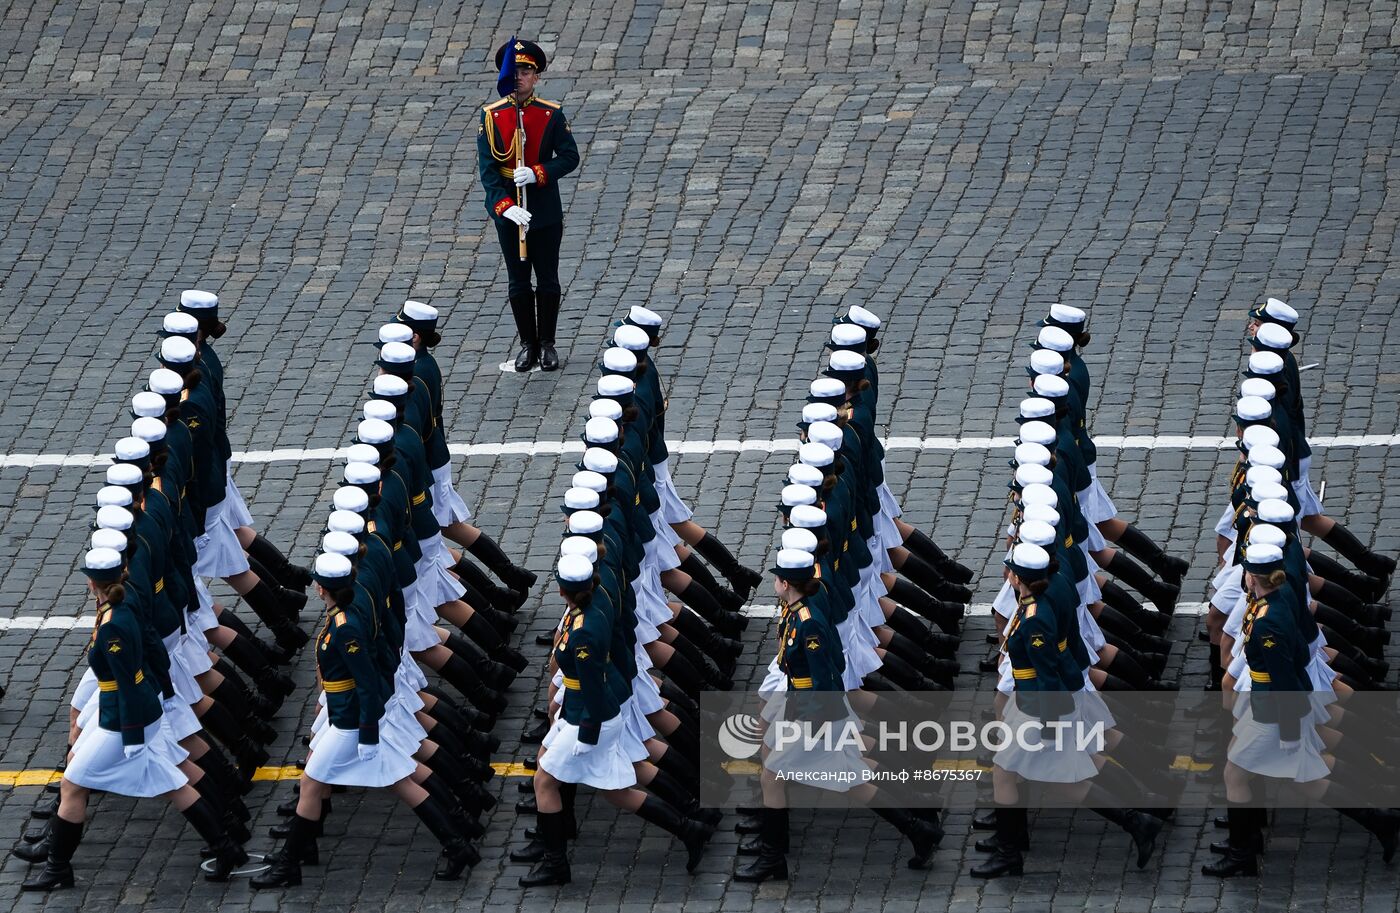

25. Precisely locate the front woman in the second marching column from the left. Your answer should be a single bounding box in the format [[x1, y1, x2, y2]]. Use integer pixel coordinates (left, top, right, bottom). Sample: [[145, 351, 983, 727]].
[[252, 555, 480, 888]]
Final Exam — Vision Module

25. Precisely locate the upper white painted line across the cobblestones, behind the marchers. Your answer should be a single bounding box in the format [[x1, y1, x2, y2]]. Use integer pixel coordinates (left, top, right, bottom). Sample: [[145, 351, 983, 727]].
[[0, 434, 1400, 469]]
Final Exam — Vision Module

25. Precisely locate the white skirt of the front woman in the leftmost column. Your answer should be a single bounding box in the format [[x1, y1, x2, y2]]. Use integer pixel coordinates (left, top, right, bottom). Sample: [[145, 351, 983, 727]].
[[63, 720, 189, 798]]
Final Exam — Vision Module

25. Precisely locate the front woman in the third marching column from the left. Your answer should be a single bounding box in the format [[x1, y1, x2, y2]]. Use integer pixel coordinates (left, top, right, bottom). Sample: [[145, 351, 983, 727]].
[[519, 555, 713, 888]]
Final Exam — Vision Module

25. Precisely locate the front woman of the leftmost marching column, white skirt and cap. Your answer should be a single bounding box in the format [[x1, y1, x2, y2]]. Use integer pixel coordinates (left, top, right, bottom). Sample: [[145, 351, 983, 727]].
[[22, 549, 248, 891]]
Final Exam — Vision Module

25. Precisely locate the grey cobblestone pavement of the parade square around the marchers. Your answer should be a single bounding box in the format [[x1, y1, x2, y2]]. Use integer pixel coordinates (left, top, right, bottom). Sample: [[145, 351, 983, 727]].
[[0, 0, 1400, 912]]
